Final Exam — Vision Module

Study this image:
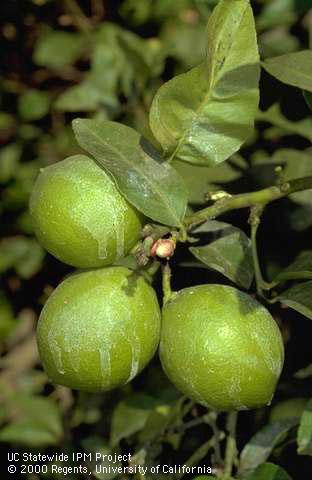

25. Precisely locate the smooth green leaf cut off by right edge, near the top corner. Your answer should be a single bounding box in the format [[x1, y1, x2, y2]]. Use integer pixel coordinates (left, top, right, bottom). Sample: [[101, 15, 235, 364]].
[[262, 50, 312, 92]]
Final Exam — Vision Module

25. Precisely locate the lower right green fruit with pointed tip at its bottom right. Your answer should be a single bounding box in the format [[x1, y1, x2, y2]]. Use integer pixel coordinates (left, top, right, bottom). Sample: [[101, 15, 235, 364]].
[[160, 285, 284, 410]]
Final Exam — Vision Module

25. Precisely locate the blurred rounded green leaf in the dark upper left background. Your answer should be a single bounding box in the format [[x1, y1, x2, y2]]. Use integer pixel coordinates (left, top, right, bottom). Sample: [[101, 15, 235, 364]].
[[33, 30, 85, 69]]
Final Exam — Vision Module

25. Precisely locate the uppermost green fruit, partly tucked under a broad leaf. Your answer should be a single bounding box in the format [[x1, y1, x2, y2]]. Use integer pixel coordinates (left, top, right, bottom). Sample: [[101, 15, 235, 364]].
[[30, 155, 142, 268]]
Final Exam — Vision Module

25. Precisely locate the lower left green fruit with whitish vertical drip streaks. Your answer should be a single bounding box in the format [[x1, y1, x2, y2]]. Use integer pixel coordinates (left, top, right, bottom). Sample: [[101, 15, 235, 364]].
[[37, 267, 160, 392]]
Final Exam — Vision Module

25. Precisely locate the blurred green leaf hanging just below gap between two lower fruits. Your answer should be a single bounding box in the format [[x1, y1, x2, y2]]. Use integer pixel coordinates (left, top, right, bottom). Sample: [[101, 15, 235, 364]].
[[110, 394, 157, 446]]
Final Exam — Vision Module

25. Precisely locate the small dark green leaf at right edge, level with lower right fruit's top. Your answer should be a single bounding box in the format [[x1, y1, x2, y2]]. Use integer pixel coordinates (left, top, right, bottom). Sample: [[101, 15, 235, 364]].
[[275, 280, 312, 320]]
